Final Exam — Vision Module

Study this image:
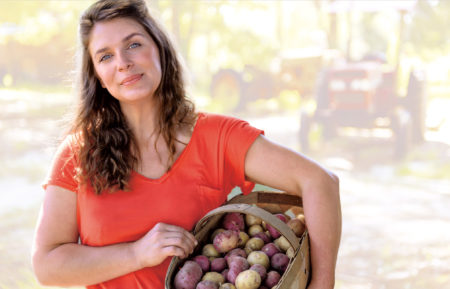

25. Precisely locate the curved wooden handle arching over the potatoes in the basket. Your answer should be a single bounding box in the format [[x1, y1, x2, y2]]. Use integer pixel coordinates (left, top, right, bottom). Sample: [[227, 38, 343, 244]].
[[194, 204, 300, 251]]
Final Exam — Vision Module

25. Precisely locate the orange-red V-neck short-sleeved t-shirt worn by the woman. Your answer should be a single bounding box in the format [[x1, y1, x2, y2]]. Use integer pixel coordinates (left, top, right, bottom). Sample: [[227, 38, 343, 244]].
[[44, 113, 264, 289]]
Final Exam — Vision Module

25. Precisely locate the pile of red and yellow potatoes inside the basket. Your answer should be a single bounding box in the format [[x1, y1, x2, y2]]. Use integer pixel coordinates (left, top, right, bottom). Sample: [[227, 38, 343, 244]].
[[174, 209, 305, 289]]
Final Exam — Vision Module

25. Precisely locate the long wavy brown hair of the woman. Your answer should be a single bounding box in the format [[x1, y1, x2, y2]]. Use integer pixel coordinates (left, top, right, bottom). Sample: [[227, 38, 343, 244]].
[[70, 0, 196, 194]]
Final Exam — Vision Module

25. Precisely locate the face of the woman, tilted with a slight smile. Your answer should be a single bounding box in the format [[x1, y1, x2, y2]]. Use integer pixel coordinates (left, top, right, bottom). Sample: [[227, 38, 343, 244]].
[[89, 18, 161, 104]]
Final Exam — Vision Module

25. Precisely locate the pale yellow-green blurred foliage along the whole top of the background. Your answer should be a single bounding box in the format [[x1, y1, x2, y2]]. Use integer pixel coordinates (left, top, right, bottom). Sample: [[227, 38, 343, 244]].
[[0, 0, 450, 94]]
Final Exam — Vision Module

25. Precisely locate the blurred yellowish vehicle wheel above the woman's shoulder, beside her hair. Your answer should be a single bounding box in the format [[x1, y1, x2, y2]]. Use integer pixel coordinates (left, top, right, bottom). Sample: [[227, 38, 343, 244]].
[[211, 69, 245, 111]]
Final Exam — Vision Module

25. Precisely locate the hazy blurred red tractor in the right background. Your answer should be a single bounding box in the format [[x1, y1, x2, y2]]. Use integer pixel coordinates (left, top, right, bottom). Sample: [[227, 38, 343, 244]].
[[300, 58, 425, 158]]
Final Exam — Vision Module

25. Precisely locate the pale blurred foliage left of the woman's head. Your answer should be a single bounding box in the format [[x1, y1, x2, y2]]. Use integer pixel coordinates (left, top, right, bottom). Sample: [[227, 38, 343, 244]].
[[0, 1, 92, 84]]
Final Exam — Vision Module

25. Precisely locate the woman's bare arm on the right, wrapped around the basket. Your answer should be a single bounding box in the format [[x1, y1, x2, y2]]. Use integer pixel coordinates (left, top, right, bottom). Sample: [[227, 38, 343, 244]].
[[245, 136, 341, 289]]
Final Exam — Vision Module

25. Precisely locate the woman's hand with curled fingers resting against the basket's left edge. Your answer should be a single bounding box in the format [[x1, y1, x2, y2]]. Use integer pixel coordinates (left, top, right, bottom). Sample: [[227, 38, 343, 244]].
[[133, 223, 197, 268]]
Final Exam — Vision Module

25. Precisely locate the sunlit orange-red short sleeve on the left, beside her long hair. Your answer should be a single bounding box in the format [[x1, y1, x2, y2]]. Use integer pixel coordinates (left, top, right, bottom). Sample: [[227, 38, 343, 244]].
[[42, 136, 78, 192]]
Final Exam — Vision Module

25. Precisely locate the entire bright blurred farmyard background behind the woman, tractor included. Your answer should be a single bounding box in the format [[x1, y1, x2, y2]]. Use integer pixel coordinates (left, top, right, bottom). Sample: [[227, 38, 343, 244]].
[[0, 0, 450, 289]]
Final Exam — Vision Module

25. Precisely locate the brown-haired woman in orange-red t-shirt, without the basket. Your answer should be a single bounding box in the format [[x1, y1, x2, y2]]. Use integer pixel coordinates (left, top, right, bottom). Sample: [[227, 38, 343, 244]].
[[32, 0, 341, 289]]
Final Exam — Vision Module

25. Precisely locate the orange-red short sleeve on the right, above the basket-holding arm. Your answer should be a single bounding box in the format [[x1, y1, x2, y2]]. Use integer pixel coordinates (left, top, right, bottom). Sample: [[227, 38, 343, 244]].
[[224, 118, 264, 194]]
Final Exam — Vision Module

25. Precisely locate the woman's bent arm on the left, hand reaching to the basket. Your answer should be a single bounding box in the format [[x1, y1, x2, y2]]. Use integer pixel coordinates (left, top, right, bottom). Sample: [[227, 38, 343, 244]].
[[32, 186, 195, 286]]
